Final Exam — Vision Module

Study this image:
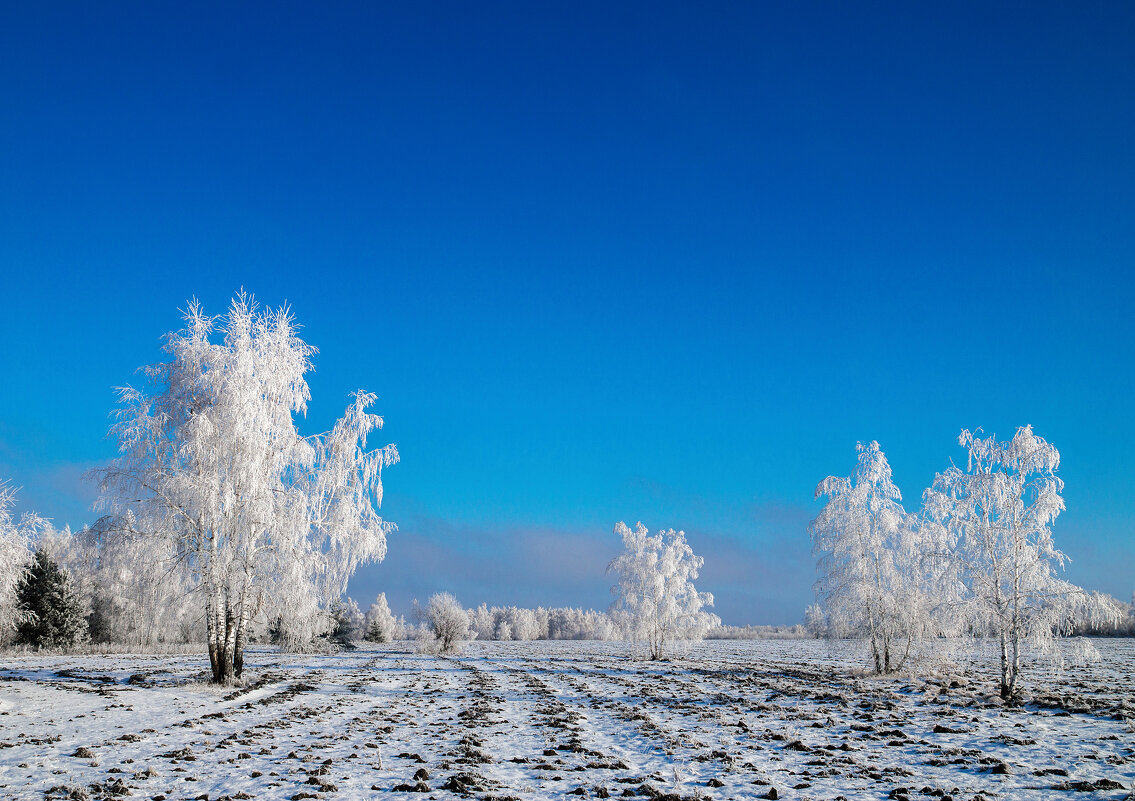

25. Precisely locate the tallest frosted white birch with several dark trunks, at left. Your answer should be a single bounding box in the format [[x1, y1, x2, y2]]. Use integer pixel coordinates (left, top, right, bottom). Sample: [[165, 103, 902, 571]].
[[96, 293, 397, 684]]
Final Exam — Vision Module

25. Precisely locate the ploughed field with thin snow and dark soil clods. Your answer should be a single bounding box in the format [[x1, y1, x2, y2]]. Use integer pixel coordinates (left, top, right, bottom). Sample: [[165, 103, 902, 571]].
[[0, 640, 1135, 801]]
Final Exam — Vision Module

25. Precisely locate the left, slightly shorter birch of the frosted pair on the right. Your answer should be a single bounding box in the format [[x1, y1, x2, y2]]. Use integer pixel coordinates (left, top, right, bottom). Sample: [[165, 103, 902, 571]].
[[809, 441, 931, 674]]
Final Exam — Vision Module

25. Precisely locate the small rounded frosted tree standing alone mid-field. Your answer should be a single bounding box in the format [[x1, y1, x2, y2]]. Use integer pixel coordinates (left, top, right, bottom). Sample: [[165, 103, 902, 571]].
[[607, 522, 721, 659]]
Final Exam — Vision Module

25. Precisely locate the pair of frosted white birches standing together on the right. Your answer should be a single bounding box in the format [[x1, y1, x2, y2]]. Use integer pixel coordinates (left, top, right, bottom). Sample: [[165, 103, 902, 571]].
[[808, 427, 1117, 698]]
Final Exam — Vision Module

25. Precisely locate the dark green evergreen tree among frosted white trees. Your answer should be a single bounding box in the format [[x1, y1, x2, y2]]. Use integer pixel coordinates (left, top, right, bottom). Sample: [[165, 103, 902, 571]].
[[16, 548, 87, 648]]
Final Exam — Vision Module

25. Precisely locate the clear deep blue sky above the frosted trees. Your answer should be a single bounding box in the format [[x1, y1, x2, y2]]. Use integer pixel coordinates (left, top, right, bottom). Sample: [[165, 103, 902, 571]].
[[0, 2, 1135, 623]]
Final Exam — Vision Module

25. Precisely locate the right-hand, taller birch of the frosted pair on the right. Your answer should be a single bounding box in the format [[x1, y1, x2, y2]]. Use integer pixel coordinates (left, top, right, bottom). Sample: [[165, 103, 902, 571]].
[[925, 425, 1115, 699]]
